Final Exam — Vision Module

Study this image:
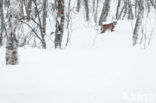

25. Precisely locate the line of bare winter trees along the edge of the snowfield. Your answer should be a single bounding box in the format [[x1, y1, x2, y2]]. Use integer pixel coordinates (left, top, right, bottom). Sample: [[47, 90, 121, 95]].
[[0, 0, 156, 65]]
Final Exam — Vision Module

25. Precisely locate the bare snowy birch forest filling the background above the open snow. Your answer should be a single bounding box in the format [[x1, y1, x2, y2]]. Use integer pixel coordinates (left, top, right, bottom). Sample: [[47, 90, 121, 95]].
[[0, 0, 156, 65]]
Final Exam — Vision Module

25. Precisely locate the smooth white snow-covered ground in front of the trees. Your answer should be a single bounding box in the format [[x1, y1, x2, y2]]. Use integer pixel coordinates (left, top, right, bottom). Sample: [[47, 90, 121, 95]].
[[0, 21, 156, 103]]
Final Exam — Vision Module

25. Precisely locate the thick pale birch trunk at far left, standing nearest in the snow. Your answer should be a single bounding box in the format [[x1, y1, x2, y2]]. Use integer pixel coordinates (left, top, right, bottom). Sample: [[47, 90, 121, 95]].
[[6, 0, 22, 65]]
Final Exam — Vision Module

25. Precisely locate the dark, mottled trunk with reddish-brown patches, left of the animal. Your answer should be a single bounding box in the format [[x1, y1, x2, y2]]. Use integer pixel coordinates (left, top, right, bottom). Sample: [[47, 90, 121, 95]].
[[54, 0, 64, 48]]
